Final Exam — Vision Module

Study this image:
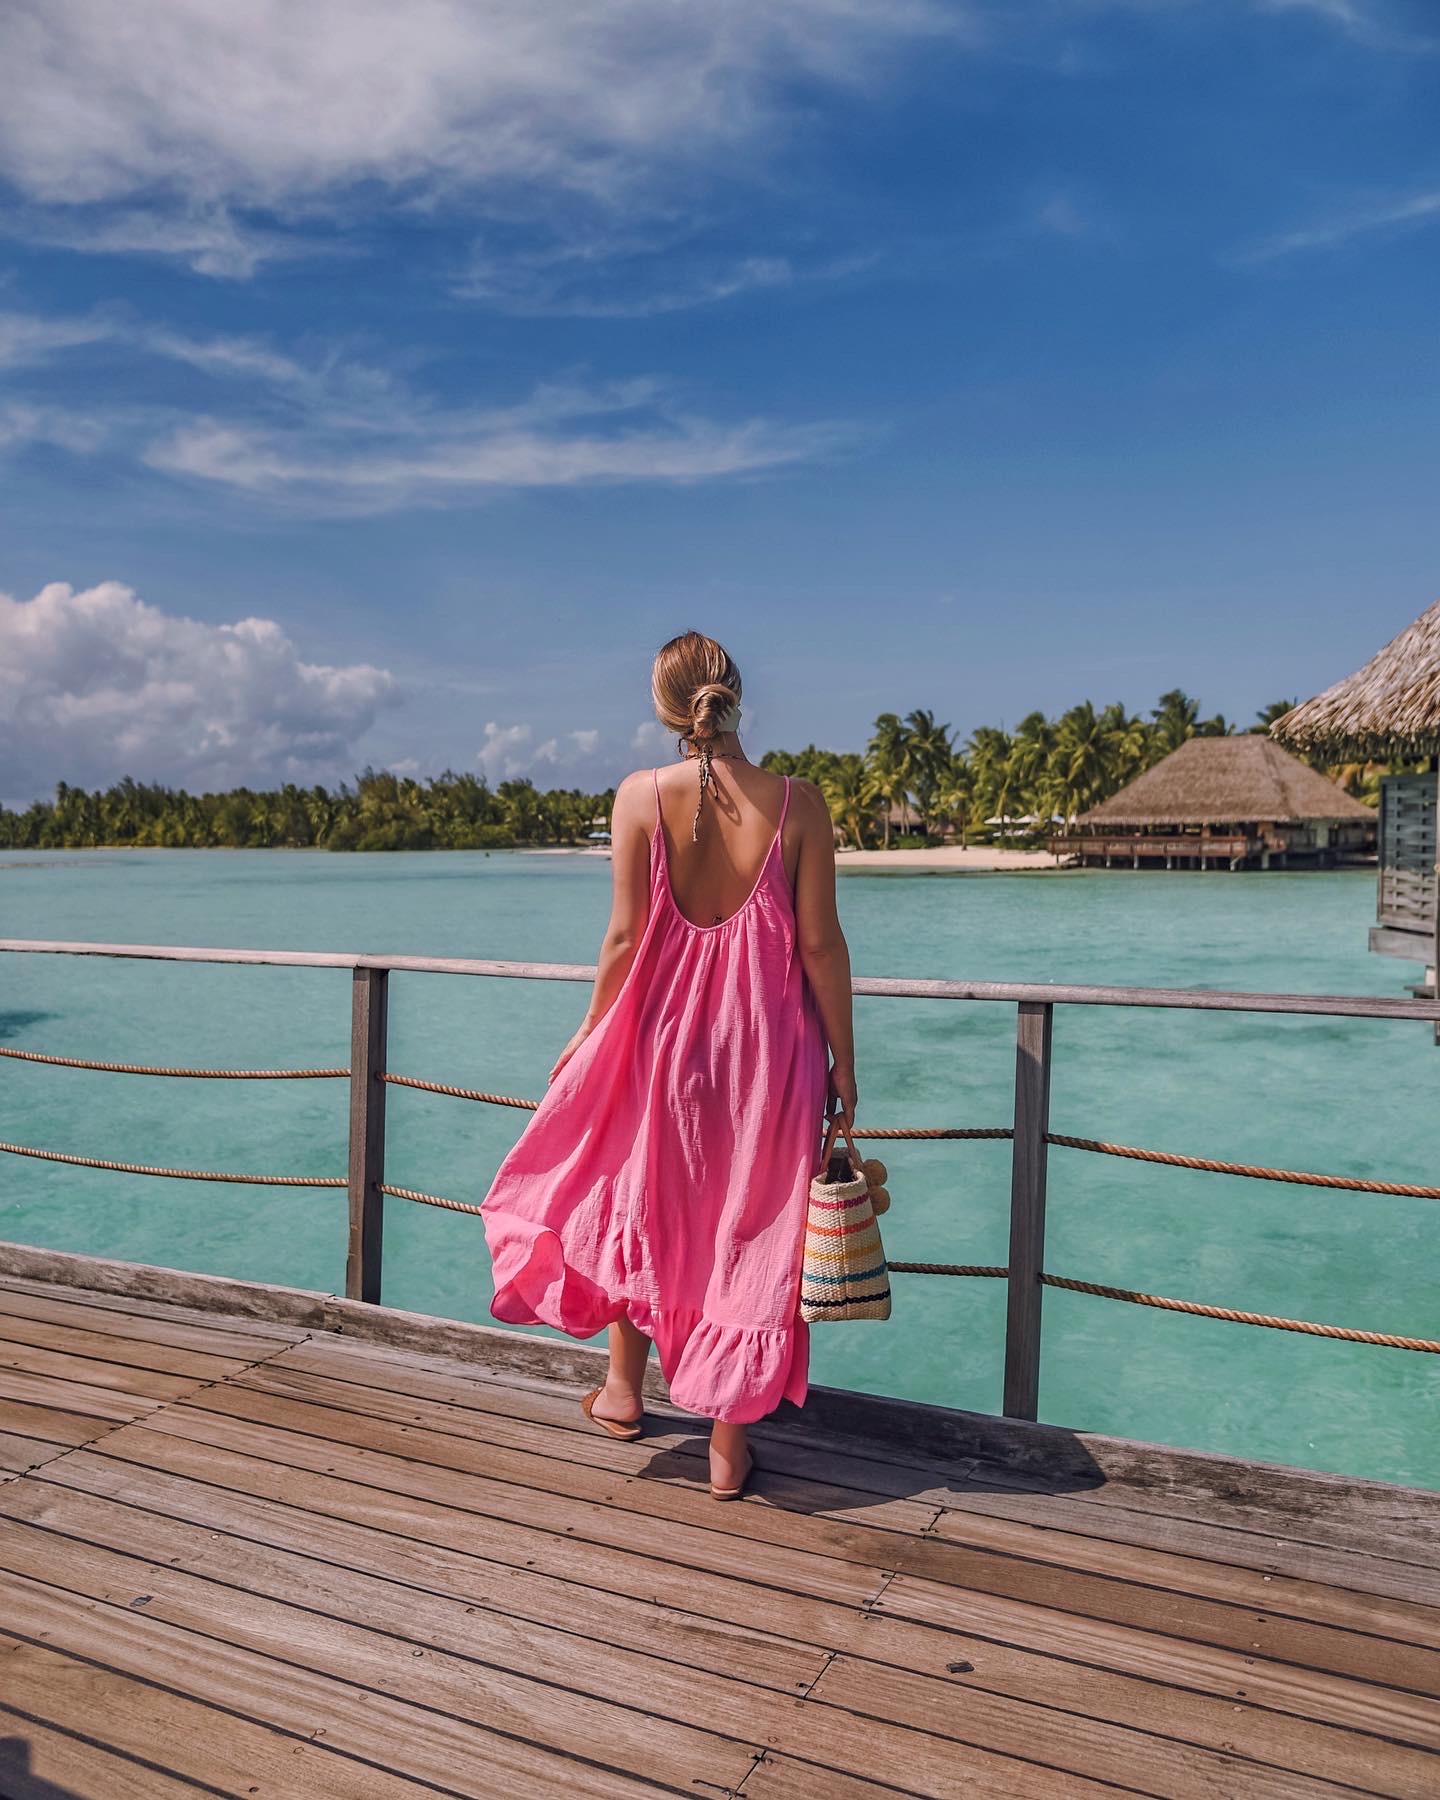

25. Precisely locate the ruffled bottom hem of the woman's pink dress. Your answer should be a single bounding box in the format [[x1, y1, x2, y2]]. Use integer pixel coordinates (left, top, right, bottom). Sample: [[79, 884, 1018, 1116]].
[[490, 1226, 810, 1424]]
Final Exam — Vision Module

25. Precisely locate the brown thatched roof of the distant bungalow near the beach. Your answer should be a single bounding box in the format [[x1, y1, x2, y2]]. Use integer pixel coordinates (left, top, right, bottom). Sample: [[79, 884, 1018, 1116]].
[[1076, 733, 1375, 828]]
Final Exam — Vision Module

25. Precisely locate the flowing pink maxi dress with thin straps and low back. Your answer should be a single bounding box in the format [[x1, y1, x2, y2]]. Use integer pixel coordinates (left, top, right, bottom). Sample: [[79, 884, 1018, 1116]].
[[481, 776, 828, 1422]]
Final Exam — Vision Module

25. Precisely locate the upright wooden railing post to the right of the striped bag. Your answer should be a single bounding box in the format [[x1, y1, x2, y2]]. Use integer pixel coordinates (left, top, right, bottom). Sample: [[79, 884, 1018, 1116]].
[[1003, 1001, 1055, 1418]]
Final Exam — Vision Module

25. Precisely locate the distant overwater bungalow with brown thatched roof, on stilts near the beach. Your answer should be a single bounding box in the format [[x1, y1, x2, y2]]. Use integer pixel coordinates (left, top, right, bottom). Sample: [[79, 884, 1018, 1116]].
[[1049, 734, 1375, 869]]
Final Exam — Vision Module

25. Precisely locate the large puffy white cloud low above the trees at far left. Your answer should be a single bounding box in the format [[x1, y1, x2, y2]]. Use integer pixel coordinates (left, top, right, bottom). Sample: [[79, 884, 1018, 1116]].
[[0, 581, 398, 799]]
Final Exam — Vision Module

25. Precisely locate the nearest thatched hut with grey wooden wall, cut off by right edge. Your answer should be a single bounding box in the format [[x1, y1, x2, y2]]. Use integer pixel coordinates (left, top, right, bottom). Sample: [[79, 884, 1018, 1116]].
[[1271, 601, 1440, 992]]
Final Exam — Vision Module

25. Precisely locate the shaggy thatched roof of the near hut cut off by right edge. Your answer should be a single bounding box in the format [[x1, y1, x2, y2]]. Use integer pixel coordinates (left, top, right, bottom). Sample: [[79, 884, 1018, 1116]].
[[1271, 601, 1440, 761]]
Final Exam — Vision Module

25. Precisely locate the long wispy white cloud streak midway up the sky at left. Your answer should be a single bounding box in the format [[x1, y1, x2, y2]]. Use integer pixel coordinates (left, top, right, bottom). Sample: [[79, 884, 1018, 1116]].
[[0, 313, 851, 515]]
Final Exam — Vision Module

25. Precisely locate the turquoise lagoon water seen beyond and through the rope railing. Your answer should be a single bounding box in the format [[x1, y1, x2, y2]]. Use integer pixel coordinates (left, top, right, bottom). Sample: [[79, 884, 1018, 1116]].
[[0, 851, 1440, 1487]]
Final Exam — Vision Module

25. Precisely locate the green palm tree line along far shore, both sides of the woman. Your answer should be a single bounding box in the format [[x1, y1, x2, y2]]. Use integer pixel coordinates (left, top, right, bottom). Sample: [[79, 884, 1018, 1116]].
[[0, 688, 1382, 850]]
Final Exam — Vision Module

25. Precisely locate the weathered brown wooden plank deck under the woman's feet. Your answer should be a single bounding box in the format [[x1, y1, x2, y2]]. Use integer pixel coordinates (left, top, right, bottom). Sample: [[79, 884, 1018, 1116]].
[[0, 1278, 1440, 1800]]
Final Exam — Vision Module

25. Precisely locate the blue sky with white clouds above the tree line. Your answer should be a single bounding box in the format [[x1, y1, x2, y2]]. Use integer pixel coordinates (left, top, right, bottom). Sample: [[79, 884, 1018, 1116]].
[[0, 0, 1440, 803]]
